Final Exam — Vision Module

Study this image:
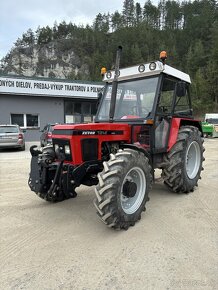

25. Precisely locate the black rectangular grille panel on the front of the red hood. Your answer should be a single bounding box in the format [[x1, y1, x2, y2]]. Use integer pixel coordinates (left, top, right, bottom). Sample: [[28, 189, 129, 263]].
[[81, 138, 98, 161]]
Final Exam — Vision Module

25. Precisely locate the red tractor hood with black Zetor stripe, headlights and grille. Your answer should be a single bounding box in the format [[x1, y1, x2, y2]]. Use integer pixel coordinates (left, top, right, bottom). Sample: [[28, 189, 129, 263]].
[[52, 123, 131, 165]]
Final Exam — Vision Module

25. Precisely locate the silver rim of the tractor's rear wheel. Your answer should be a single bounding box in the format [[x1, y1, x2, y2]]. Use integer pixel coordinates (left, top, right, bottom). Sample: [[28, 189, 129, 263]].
[[185, 141, 201, 179]]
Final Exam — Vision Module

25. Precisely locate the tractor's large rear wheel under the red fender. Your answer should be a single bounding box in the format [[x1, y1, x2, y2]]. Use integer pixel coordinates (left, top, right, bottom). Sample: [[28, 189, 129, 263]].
[[162, 126, 205, 193]]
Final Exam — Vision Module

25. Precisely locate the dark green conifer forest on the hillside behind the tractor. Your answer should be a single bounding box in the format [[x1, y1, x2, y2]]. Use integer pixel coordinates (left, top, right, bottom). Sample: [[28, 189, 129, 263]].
[[0, 0, 218, 112]]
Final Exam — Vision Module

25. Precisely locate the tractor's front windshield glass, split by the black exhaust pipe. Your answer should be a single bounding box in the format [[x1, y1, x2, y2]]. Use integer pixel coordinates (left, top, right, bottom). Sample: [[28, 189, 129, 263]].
[[97, 76, 158, 121]]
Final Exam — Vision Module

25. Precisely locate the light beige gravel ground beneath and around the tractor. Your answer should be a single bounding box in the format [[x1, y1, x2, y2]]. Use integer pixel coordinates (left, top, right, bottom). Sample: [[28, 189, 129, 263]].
[[0, 139, 218, 290]]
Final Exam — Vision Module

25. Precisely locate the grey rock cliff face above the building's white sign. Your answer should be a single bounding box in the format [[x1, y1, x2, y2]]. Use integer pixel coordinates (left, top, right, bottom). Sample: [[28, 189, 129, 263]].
[[1, 42, 89, 79]]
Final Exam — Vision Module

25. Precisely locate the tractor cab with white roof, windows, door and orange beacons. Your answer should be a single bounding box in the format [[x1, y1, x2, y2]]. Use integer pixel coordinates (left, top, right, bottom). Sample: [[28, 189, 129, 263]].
[[95, 53, 193, 151]]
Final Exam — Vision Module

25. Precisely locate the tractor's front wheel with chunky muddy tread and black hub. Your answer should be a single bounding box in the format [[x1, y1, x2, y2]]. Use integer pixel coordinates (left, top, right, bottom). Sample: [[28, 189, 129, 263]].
[[94, 149, 152, 230]]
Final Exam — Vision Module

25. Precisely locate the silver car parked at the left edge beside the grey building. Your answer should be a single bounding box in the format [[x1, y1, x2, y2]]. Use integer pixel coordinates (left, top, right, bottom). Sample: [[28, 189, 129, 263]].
[[0, 125, 25, 150]]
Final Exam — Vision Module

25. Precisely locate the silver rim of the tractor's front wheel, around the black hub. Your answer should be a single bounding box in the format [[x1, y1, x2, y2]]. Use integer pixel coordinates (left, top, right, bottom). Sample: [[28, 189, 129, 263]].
[[120, 167, 146, 214]]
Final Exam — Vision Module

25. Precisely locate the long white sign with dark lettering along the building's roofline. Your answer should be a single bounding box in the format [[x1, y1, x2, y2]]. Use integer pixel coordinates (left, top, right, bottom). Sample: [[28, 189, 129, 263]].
[[0, 77, 103, 98]]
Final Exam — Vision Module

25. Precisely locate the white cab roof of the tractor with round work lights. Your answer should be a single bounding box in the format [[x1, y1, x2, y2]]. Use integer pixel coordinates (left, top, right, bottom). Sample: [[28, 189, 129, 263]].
[[103, 61, 191, 83]]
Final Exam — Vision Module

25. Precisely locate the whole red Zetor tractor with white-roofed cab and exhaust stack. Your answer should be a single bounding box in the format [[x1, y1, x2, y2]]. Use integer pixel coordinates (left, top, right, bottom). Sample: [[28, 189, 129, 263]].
[[29, 47, 204, 229]]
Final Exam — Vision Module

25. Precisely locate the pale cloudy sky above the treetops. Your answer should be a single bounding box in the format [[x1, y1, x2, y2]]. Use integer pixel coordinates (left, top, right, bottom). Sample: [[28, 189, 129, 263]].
[[0, 0, 157, 60]]
